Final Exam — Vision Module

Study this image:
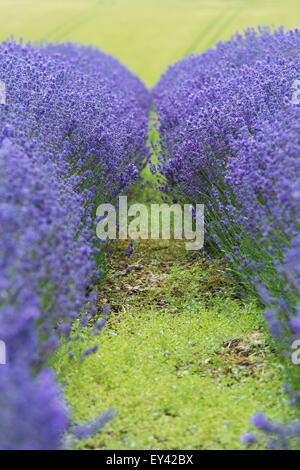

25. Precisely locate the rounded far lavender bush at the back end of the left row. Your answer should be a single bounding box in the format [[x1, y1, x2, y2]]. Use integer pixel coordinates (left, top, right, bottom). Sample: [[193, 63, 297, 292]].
[[0, 42, 149, 206]]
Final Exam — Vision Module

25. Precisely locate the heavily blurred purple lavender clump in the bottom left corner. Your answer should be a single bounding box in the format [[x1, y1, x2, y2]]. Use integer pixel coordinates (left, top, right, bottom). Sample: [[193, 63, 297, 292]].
[[0, 363, 68, 450]]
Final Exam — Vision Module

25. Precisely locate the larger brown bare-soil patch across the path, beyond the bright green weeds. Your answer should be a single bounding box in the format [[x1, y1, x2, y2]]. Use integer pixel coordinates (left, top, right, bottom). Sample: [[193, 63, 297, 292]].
[[99, 240, 234, 324]]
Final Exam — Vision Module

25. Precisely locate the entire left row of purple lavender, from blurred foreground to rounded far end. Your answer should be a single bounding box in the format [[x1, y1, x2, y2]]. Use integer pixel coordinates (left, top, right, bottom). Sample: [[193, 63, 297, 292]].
[[0, 41, 149, 449]]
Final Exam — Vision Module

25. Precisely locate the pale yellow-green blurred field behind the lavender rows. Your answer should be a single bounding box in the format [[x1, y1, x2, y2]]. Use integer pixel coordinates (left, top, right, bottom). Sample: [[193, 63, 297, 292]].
[[0, 0, 300, 86]]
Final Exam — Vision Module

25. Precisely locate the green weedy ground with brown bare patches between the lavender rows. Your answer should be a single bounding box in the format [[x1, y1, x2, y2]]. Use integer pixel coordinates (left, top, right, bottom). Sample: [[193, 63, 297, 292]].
[[52, 241, 291, 449]]
